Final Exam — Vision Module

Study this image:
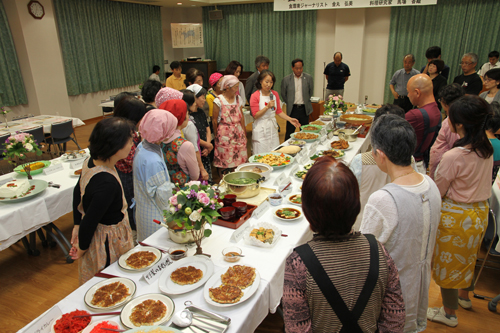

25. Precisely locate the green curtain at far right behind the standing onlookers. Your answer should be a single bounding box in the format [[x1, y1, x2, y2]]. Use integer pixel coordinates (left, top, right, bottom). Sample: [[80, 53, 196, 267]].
[[384, 0, 500, 103]]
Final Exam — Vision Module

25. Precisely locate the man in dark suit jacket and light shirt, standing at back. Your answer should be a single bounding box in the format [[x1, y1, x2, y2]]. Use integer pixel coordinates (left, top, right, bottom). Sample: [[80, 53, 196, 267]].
[[281, 59, 314, 140]]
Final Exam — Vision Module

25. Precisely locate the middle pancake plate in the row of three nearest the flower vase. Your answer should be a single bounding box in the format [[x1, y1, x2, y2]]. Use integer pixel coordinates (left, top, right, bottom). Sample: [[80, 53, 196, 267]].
[[159, 256, 214, 295]]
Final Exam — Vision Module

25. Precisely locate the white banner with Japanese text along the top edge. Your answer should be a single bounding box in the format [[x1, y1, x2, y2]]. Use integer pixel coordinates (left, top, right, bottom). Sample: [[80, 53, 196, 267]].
[[274, 0, 437, 11]]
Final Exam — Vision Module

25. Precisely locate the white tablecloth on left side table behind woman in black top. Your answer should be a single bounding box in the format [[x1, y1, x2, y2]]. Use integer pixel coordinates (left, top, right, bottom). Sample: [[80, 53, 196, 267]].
[[0, 158, 83, 251]]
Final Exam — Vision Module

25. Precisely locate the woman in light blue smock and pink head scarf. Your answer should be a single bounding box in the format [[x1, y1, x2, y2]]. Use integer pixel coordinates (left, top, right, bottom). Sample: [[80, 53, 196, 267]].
[[133, 109, 177, 241]]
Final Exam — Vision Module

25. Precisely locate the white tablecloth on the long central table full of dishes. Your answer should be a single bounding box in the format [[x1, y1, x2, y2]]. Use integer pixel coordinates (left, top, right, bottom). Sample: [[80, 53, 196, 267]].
[[20, 129, 369, 332]]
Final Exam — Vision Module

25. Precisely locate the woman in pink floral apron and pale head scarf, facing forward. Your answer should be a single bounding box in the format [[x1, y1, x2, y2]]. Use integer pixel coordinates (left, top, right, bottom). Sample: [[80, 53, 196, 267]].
[[212, 75, 247, 173]]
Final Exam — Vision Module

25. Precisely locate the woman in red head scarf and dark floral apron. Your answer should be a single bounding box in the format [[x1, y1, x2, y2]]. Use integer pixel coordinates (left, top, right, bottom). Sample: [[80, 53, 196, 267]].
[[160, 100, 200, 187]]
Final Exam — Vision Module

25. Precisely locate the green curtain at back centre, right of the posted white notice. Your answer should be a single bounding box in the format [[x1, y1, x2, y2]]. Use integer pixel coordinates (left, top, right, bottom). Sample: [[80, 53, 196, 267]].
[[203, 3, 316, 92]]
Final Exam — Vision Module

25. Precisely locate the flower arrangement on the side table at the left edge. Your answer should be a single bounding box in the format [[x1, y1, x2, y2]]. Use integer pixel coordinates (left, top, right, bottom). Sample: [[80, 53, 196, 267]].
[[3, 132, 42, 179]]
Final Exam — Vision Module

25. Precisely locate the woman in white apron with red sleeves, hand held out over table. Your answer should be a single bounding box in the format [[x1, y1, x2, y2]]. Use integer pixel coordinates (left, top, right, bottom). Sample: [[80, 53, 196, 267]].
[[250, 70, 300, 155]]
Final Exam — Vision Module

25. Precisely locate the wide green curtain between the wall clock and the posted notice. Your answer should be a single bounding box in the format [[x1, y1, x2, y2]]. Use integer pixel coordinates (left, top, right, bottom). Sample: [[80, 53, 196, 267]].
[[54, 0, 163, 95]]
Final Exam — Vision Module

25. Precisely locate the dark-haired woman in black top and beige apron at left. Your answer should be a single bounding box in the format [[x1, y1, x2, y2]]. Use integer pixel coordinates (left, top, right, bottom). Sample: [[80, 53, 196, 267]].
[[70, 117, 134, 284]]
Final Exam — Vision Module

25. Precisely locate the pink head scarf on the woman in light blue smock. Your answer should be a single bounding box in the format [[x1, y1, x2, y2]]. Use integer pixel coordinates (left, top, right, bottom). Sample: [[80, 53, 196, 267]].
[[139, 109, 177, 143]]
